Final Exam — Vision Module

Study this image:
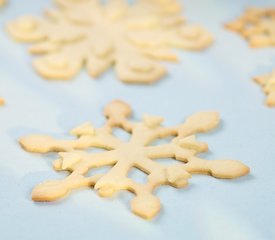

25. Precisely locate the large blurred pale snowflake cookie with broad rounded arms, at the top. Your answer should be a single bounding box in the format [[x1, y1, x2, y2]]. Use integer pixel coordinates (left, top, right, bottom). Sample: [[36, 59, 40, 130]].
[[7, 0, 212, 83]]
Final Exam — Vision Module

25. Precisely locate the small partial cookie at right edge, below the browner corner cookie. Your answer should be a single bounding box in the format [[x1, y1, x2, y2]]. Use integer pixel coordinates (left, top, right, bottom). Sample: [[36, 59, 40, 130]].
[[254, 70, 275, 107]]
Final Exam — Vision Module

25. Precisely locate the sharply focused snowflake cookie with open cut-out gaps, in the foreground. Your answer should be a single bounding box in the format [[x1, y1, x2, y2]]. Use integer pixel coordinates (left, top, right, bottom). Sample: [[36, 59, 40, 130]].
[[20, 100, 249, 219]]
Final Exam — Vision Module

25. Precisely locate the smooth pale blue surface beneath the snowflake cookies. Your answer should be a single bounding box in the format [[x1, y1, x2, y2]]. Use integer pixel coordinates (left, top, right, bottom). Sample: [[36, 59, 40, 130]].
[[0, 0, 275, 240]]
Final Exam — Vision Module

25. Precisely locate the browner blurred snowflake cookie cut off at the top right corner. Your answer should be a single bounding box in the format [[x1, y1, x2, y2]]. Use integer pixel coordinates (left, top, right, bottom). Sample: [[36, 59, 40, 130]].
[[226, 8, 275, 47]]
